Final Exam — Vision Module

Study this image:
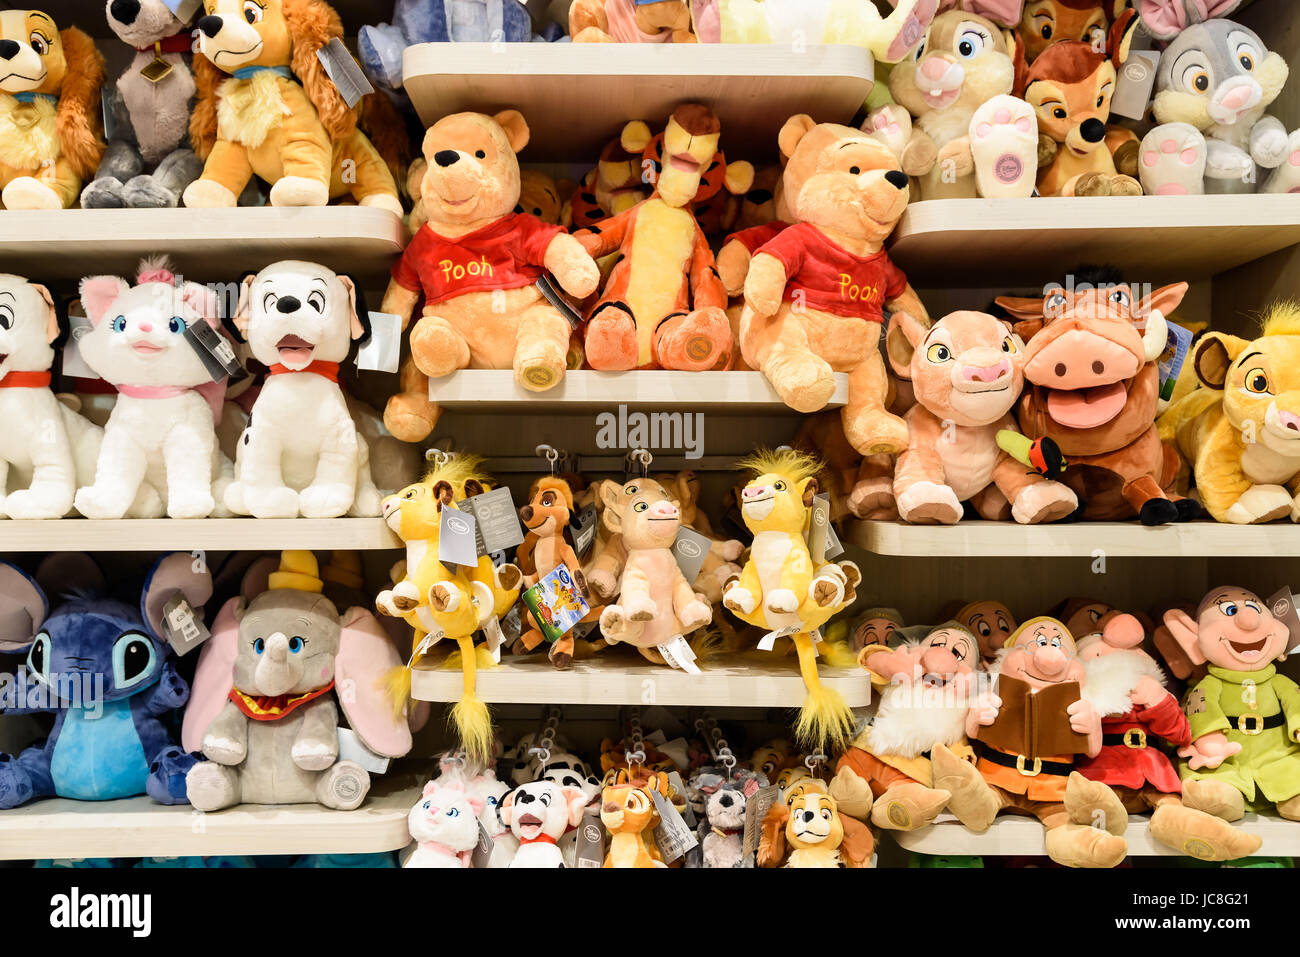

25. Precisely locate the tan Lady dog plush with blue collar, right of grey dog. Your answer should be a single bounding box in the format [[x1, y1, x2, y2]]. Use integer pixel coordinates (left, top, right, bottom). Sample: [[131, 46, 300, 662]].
[[185, 0, 402, 216]]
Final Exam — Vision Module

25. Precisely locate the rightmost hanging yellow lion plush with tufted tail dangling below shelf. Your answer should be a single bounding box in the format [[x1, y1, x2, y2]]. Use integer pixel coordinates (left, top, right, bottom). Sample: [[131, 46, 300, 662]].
[[723, 451, 862, 750]]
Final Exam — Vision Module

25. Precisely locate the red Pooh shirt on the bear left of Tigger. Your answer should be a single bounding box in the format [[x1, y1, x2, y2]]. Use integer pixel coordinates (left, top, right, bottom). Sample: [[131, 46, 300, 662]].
[[393, 213, 564, 306]]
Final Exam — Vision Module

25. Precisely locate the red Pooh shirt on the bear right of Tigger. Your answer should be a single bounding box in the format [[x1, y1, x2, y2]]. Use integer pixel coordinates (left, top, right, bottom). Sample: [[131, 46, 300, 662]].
[[759, 222, 907, 322]]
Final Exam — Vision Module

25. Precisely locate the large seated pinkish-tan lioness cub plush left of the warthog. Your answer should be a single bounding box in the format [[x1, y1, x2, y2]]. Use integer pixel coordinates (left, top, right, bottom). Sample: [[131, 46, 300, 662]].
[[888, 312, 1079, 525]]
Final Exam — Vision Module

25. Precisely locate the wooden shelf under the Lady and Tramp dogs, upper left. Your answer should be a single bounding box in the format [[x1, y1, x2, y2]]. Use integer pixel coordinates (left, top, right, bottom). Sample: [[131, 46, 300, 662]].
[[0, 208, 407, 282]]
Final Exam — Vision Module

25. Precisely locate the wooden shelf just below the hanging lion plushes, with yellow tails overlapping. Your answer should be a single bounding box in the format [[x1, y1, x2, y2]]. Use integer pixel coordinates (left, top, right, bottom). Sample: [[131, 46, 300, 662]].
[[411, 649, 871, 707]]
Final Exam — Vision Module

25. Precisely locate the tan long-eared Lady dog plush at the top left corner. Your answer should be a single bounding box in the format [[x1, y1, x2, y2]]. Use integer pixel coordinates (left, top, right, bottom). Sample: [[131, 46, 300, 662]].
[[0, 10, 104, 209]]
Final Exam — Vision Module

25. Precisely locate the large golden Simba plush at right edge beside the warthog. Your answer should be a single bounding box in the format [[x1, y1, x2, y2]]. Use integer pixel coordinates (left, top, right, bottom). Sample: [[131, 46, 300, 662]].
[[1160, 303, 1300, 525]]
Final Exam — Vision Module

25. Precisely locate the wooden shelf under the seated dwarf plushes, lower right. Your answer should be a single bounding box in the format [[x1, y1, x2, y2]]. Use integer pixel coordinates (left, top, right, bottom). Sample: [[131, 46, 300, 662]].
[[889, 814, 1300, 857]]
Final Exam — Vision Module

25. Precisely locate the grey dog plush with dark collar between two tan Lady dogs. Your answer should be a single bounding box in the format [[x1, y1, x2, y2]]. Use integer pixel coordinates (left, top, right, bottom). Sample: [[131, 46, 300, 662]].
[[81, 0, 203, 209]]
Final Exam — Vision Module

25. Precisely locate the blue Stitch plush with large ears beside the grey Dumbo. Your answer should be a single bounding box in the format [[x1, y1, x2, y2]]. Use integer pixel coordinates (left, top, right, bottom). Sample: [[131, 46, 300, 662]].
[[0, 553, 212, 809]]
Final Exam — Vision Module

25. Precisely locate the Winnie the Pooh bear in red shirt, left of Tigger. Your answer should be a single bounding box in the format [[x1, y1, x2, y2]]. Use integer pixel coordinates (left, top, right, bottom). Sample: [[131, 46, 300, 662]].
[[382, 109, 599, 442]]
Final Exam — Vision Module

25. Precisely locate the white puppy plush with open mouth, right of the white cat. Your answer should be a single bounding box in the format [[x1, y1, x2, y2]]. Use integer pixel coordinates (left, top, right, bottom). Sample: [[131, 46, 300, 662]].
[[226, 261, 380, 519]]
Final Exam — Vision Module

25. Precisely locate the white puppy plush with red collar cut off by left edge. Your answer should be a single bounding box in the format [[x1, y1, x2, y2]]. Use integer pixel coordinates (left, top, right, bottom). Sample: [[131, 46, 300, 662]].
[[0, 273, 103, 519]]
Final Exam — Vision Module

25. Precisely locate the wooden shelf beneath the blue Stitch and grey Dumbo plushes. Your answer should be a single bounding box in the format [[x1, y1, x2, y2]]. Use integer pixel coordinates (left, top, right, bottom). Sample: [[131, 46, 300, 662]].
[[0, 775, 421, 861]]
